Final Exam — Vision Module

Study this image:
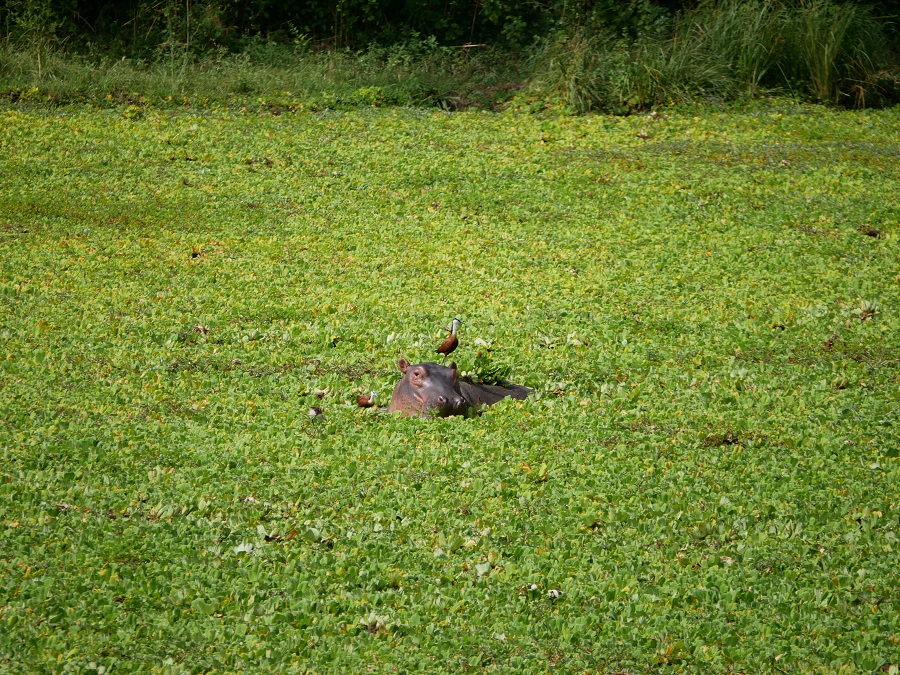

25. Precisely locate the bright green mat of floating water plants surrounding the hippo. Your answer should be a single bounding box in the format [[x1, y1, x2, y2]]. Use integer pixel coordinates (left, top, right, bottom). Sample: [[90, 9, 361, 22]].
[[0, 102, 900, 673]]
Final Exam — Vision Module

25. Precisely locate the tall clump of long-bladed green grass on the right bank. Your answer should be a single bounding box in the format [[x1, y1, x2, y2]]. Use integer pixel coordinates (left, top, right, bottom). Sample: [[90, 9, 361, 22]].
[[533, 0, 892, 112]]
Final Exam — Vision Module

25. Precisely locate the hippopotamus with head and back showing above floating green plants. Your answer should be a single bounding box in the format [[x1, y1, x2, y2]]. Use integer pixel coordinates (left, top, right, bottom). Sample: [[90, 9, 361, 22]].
[[388, 359, 531, 417]]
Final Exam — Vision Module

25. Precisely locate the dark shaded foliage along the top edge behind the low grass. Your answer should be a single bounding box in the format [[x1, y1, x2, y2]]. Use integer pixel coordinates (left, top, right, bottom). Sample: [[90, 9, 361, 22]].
[[0, 0, 682, 51]]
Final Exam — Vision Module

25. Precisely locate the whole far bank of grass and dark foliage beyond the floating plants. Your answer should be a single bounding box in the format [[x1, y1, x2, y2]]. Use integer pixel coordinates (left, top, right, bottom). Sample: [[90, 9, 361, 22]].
[[0, 0, 900, 109]]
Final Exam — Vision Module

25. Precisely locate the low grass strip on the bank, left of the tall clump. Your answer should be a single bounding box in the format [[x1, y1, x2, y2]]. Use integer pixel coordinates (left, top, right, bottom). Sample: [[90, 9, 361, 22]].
[[0, 39, 522, 108]]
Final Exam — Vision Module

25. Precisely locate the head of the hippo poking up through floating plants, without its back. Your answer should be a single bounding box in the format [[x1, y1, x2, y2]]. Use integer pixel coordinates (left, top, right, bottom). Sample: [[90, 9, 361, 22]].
[[388, 359, 469, 417]]
